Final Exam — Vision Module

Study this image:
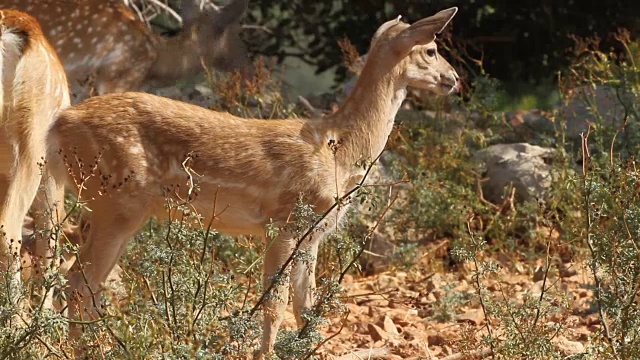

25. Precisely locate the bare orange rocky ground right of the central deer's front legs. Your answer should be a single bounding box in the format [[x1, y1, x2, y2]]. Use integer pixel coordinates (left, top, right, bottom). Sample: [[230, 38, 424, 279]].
[[284, 240, 600, 360]]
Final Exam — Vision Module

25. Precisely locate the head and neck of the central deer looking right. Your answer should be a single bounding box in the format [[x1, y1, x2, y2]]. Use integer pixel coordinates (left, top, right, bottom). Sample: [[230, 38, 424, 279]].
[[328, 8, 459, 167]]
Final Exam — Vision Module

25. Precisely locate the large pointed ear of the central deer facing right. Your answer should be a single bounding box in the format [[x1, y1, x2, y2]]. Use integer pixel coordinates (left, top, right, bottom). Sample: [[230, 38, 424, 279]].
[[392, 7, 458, 55]]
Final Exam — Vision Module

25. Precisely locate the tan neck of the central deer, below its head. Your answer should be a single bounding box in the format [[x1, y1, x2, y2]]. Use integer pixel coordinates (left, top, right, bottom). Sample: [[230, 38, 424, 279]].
[[328, 60, 407, 167]]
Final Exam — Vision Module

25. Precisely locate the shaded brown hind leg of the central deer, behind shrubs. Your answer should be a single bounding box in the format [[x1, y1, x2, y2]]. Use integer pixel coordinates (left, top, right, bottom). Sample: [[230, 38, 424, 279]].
[[66, 197, 149, 348]]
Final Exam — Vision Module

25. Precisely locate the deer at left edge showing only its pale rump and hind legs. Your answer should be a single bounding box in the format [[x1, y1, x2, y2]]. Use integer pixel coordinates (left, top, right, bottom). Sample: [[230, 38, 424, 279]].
[[0, 10, 69, 307]]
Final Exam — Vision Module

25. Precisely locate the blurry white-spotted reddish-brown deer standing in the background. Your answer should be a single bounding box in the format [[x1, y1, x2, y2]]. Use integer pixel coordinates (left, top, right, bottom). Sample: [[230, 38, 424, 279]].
[[2, 0, 249, 97]]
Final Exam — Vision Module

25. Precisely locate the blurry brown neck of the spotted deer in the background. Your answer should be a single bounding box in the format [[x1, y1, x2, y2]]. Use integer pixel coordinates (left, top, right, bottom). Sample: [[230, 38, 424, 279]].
[[147, 29, 202, 83]]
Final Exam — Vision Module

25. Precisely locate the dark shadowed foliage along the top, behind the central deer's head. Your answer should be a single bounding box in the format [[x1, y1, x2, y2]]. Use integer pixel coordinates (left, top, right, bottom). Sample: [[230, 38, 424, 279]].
[[242, 0, 640, 82]]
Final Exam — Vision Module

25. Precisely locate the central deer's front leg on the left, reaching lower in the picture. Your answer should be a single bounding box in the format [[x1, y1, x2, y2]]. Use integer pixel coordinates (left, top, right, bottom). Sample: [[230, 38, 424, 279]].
[[257, 238, 294, 359]]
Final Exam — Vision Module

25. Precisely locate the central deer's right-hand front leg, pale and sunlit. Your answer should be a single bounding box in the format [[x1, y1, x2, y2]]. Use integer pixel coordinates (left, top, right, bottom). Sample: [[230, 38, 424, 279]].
[[291, 240, 320, 327]]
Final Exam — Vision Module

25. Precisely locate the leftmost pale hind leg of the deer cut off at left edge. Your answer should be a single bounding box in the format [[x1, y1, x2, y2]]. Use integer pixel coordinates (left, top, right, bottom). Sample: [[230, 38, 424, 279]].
[[0, 129, 45, 305]]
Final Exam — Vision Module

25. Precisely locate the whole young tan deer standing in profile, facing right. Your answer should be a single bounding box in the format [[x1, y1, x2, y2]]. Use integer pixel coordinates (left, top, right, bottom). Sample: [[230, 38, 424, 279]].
[[48, 8, 458, 354]]
